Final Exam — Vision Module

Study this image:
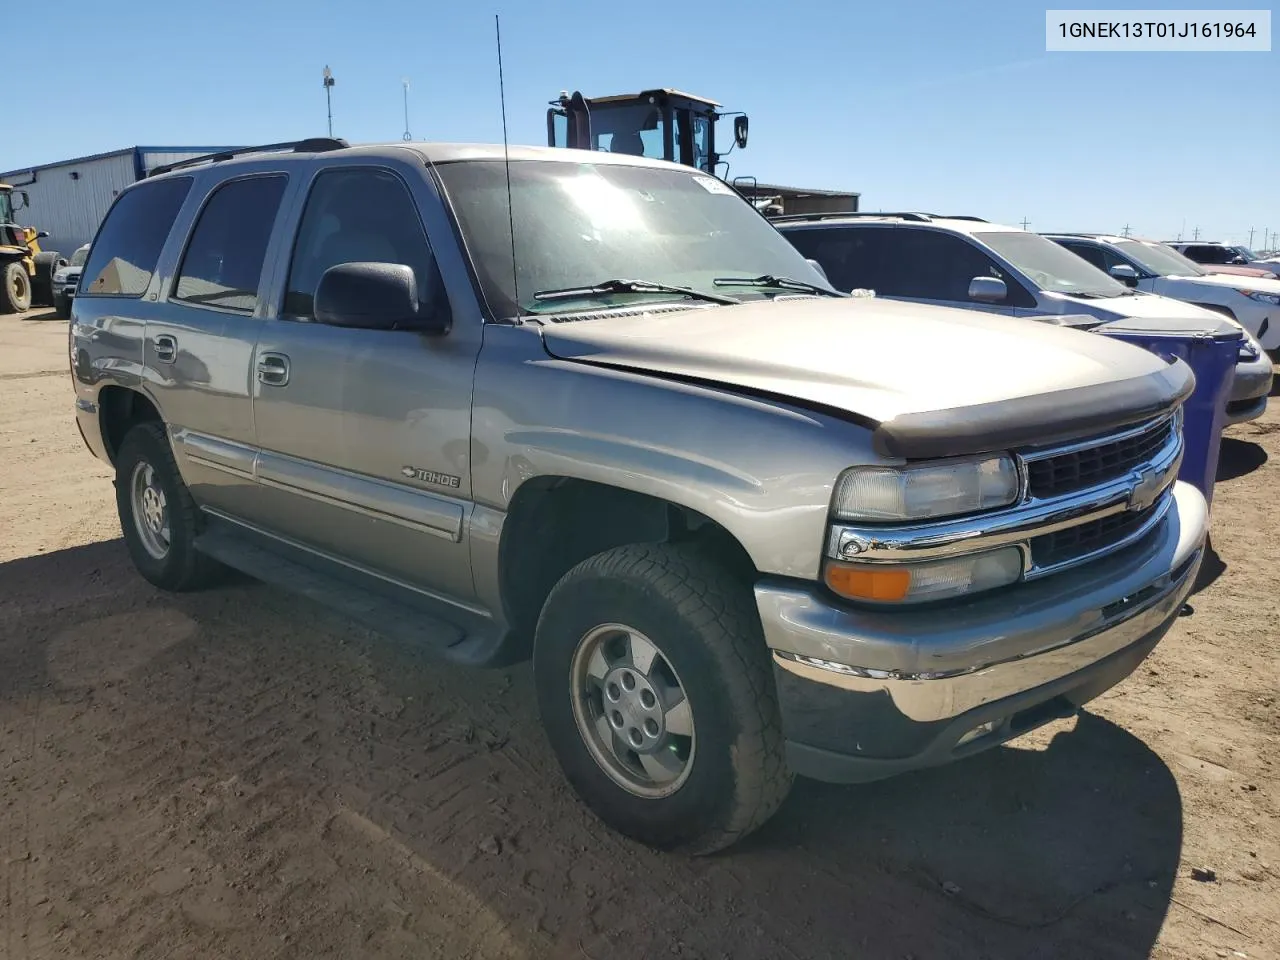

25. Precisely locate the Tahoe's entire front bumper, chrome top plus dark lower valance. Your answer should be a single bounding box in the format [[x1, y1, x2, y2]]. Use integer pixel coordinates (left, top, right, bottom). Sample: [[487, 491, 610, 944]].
[[756, 483, 1208, 782]]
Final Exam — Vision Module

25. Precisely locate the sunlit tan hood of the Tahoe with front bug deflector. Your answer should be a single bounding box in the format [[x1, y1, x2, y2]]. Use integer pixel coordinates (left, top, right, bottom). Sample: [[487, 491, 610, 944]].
[[541, 297, 1194, 457]]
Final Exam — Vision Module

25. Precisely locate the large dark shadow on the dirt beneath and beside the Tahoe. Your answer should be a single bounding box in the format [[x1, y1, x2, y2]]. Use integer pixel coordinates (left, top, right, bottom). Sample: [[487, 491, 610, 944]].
[[0, 540, 1183, 960]]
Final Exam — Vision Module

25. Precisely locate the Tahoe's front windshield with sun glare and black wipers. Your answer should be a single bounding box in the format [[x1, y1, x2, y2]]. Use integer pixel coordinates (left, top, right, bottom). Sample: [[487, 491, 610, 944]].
[[435, 160, 831, 316]]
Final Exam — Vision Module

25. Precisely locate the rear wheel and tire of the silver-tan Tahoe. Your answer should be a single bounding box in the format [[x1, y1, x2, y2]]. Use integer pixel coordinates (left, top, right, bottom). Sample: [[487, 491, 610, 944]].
[[115, 421, 219, 591]]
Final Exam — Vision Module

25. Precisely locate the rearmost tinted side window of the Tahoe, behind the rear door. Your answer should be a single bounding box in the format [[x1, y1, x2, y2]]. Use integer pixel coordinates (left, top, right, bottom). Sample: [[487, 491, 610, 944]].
[[79, 177, 191, 297]]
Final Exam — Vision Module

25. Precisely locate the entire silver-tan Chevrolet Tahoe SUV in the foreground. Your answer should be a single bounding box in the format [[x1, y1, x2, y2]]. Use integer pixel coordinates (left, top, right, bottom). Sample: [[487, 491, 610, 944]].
[[69, 141, 1207, 852]]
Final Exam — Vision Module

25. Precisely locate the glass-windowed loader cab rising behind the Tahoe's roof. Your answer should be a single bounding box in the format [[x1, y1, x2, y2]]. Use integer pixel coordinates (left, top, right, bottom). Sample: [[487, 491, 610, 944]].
[[547, 90, 748, 177]]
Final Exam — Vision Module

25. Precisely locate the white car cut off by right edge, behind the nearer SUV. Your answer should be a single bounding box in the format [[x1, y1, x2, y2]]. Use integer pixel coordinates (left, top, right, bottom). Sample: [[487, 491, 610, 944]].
[[1044, 233, 1280, 351]]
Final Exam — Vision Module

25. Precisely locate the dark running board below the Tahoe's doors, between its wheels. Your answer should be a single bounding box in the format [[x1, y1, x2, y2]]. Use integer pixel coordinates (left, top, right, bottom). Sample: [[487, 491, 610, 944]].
[[195, 524, 470, 660]]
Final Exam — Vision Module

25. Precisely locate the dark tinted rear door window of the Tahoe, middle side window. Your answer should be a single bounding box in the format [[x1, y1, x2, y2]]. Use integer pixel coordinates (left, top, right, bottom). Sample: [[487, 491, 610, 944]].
[[174, 177, 288, 314]]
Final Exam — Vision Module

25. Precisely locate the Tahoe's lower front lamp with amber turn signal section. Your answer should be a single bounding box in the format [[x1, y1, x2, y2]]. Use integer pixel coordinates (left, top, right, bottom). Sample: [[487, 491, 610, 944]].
[[823, 547, 1023, 603]]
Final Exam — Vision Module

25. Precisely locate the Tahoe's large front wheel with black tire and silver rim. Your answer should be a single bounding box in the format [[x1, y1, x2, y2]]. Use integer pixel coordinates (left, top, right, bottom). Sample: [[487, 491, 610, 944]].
[[534, 544, 791, 854]]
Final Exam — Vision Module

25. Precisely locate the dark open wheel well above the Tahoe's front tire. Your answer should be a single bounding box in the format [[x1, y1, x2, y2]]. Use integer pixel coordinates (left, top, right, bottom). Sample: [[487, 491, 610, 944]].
[[498, 477, 756, 655]]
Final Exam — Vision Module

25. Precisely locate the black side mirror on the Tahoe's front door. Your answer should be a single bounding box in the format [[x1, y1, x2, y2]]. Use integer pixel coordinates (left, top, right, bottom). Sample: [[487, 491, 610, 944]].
[[314, 262, 449, 333]]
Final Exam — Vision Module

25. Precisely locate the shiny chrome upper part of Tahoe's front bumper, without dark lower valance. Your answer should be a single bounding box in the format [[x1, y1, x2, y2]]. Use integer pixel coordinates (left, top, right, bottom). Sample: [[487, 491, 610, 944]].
[[755, 483, 1208, 722]]
